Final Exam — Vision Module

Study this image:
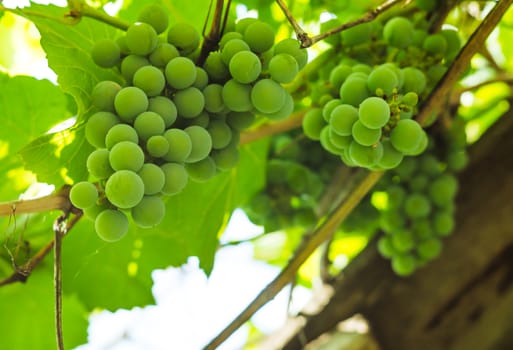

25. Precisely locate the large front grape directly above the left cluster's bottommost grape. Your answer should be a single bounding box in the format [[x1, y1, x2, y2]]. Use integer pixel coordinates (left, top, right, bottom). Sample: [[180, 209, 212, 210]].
[[105, 170, 144, 209]]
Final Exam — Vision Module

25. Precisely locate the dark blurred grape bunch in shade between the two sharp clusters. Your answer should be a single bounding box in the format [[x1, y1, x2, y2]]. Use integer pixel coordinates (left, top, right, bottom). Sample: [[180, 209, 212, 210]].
[[243, 134, 340, 232]]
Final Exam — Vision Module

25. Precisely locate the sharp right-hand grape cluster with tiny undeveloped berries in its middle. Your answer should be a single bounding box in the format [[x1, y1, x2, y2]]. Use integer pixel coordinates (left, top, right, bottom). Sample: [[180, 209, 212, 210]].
[[303, 63, 427, 170]]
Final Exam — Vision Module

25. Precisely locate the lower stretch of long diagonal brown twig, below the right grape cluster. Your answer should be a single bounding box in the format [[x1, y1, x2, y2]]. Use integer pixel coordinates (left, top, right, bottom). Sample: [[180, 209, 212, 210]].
[[204, 172, 383, 350]]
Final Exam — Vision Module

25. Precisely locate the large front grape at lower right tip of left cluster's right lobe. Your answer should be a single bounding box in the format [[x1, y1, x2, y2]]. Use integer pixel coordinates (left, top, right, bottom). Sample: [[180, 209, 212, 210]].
[[251, 79, 285, 113]]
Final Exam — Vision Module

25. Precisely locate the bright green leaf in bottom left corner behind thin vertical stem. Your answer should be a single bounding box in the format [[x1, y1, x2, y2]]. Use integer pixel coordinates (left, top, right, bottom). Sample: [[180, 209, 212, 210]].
[[0, 263, 87, 350]]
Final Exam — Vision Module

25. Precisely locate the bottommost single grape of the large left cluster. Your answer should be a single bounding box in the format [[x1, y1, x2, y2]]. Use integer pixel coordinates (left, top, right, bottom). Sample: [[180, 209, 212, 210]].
[[94, 209, 128, 242]]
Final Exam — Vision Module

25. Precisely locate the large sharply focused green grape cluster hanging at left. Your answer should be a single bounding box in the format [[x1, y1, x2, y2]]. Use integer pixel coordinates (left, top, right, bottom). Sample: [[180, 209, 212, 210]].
[[70, 4, 307, 241]]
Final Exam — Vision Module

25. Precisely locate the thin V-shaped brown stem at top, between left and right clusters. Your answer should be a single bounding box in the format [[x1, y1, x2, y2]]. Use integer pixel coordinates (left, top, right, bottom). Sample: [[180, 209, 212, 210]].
[[276, 0, 405, 48]]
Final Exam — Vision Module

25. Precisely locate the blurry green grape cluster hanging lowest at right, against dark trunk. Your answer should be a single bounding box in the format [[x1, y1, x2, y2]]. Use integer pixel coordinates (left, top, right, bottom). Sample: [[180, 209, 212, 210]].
[[372, 123, 468, 276]]
